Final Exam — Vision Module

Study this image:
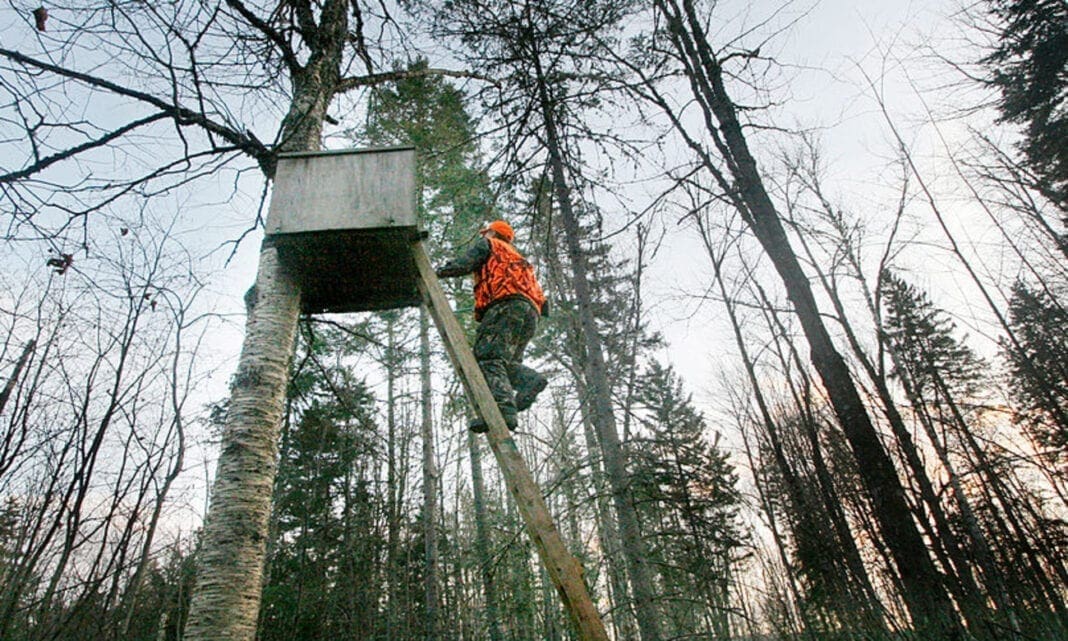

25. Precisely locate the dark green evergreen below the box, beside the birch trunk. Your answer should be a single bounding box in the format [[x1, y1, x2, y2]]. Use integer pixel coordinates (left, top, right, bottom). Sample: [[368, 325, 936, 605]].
[[260, 329, 380, 641]]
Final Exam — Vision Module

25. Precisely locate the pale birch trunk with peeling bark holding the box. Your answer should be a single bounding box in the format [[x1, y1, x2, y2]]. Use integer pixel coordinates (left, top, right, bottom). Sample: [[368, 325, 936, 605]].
[[185, 26, 339, 641]]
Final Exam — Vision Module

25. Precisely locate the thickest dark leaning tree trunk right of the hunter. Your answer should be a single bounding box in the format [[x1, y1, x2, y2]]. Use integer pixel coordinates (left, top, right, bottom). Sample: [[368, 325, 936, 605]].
[[640, 5, 961, 637]]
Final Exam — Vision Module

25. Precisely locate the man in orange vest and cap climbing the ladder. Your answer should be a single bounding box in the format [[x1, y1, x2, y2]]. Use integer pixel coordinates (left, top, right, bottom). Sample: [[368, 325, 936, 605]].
[[437, 220, 549, 433]]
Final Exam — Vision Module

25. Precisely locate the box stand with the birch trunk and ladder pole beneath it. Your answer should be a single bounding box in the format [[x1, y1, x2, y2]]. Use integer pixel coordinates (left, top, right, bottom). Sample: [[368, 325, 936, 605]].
[[187, 147, 608, 641]]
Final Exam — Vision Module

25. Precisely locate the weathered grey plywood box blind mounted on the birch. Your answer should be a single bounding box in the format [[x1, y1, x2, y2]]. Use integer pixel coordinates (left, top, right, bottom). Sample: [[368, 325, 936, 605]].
[[266, 147, 422, 313]]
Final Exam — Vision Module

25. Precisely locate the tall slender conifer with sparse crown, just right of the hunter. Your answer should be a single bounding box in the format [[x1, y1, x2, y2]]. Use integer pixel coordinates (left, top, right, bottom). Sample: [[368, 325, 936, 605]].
[[429, 0, 662, 641]]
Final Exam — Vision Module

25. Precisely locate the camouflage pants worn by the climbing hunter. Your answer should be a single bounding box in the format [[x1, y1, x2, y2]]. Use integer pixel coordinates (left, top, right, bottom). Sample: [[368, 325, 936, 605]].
[[474, 298, 540, 418]]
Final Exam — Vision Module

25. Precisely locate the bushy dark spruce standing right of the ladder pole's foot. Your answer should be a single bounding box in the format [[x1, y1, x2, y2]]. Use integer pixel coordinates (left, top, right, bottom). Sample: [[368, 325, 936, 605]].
[[629, 361, 744, 639]]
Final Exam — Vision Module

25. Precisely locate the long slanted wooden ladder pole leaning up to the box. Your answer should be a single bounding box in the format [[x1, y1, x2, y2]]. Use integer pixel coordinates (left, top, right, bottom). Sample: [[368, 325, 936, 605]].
[[412, 243, 609, 641]]
